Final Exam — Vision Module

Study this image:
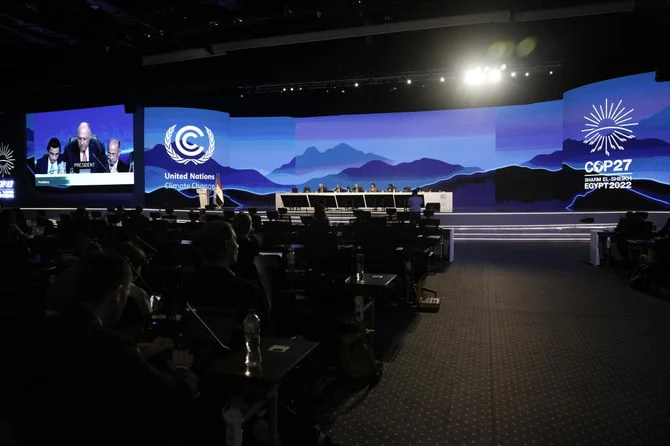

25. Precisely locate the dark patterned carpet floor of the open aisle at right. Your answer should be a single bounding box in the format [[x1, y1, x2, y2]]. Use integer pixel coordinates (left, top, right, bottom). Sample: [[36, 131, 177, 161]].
[[328, 242, 670, 446]]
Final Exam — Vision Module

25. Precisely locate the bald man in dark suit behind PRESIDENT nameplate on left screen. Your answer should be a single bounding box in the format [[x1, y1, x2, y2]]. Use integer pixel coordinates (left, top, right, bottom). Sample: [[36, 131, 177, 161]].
[[65, 122, 107, 173]]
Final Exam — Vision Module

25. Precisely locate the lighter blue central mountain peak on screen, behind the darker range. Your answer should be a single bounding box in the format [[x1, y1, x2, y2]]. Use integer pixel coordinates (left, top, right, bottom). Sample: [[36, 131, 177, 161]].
[[268, 143, 393, 181]]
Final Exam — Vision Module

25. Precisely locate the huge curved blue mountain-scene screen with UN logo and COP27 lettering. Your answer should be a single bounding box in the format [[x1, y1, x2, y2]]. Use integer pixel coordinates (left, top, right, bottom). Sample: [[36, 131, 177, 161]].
[[145, 74, 670, 212]]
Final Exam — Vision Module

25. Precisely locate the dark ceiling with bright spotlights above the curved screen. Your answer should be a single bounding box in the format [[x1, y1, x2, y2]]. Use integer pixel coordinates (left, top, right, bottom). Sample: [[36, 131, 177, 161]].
[[0, 0, 668, 114]]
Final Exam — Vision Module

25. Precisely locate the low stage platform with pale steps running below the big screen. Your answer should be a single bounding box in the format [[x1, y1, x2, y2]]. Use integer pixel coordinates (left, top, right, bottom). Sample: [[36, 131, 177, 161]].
[[17, 208, 670, 243]]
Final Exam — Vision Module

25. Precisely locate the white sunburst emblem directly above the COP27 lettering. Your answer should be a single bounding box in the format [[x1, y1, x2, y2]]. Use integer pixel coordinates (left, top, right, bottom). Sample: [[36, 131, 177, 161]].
[[582, 99, 638, 156]]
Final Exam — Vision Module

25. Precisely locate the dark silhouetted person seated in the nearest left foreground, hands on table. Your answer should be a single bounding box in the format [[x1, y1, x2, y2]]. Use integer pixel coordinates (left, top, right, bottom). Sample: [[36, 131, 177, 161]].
[[14, 252, 197, 445]]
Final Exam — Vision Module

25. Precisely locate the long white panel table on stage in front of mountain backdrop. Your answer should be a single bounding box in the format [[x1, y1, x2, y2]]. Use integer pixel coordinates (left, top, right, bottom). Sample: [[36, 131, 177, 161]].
[[275, 192, 454, 212]]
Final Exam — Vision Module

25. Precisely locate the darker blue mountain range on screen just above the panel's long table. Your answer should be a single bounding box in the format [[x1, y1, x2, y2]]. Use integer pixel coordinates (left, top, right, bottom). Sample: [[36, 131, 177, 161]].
[[300, 158, 481, 189]]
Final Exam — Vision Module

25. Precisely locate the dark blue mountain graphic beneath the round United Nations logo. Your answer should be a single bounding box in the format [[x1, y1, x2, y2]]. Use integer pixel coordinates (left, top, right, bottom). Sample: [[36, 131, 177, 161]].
[[144, 144, 286, 193]]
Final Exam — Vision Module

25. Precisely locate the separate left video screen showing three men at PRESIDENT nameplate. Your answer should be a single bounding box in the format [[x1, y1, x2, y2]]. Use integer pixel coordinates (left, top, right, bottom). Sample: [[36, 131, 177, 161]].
[[26, 105, 135, 188]]
